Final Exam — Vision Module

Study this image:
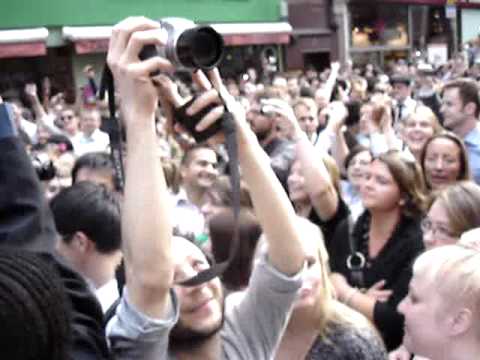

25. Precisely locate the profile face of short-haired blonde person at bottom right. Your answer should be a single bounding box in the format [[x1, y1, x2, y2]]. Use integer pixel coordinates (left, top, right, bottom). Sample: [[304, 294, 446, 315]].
[[398, 273, 447, 359]]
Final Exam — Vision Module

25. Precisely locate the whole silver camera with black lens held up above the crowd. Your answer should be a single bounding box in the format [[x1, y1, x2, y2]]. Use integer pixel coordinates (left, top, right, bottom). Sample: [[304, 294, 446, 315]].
[[139, 17, 225, 71]]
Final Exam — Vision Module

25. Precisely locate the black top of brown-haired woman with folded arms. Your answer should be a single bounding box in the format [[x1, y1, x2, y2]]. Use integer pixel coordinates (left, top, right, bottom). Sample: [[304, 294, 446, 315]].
[[330, 211, 424, 351]]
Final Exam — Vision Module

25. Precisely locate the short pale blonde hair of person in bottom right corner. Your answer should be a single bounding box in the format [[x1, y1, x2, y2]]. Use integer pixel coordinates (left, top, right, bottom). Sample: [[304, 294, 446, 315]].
[[413, 243, 480, 336]]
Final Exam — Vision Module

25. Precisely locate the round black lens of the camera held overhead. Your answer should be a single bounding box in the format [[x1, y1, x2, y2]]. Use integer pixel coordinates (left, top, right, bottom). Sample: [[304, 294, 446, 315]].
[[176, 26, 224, 70]]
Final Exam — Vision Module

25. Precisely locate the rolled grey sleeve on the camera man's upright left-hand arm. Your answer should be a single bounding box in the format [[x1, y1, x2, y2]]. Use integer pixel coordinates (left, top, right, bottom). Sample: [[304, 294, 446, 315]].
[[106, 289, 179, 360]]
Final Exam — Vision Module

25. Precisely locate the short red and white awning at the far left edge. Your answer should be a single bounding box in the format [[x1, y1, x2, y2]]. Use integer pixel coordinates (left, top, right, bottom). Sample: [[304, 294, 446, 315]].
[[0, 28, 48, 58]]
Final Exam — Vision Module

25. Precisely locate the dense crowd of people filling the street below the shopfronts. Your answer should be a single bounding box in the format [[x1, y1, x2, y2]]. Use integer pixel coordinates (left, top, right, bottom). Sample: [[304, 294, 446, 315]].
[[0, 18, 480, 360]]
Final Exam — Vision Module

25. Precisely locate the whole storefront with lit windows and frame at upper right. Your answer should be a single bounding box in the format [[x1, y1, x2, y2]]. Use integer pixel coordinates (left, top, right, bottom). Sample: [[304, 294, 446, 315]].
[[347, 0, 455, 67]]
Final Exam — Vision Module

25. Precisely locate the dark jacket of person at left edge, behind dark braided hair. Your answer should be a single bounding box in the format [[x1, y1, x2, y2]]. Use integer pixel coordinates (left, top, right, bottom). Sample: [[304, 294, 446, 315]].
[[0, 136, 109, 360]]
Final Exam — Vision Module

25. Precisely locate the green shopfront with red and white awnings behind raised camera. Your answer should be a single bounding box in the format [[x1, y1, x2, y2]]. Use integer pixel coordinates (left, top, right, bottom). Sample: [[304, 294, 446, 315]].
[[0, 0, 292, 101]]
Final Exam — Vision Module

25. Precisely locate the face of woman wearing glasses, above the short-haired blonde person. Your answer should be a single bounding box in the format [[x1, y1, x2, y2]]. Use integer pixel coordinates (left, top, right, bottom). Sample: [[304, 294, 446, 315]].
[[422, 200, 458, 250]]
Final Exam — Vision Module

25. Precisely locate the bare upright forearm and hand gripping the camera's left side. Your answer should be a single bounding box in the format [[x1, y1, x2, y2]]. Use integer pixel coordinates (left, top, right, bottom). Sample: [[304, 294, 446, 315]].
[[107, 18, 173, 318]]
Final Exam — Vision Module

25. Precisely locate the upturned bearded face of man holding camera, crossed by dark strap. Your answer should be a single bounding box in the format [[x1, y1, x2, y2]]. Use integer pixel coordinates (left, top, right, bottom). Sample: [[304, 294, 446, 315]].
[[171, 238, 225, 343]]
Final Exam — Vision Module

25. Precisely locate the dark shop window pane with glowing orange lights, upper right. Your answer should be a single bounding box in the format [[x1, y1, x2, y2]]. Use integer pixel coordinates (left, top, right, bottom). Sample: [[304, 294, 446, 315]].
[[350, 4, 409, 48]]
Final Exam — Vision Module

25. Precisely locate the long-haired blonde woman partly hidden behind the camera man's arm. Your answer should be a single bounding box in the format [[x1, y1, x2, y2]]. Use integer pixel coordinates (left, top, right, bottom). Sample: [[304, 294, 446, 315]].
[[276, 218, 387, 360]]
